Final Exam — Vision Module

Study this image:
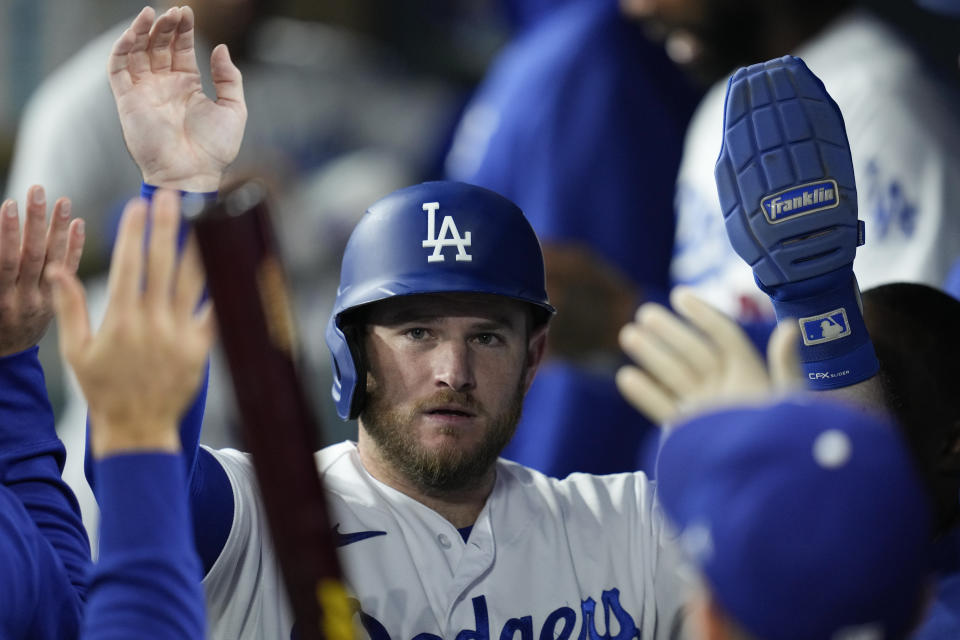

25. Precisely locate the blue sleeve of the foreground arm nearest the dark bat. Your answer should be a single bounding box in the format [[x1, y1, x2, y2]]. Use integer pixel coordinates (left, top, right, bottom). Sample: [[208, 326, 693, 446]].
[[82, 453, 206, 640]]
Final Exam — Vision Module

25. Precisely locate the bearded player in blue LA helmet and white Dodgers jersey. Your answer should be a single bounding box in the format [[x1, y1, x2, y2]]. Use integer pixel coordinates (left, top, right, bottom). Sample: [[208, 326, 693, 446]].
[[97, 9, 684, 640]]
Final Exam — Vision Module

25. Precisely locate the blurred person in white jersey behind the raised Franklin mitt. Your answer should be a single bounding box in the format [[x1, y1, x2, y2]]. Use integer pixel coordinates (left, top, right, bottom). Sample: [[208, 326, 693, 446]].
[[625, 0, 960, 341]]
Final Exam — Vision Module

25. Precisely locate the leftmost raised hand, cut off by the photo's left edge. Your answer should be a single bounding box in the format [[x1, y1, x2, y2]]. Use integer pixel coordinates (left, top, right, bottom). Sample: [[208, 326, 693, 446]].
[[0, 185, 84, 357]]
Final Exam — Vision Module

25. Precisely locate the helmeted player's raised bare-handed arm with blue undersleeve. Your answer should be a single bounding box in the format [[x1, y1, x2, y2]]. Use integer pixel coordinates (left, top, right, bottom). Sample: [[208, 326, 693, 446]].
[[96, 6, 247, 569]]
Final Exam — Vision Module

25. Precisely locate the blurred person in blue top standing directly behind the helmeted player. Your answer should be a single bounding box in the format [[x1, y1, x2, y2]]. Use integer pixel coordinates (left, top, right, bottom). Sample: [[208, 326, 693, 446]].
[[445, 0, 699, 478]]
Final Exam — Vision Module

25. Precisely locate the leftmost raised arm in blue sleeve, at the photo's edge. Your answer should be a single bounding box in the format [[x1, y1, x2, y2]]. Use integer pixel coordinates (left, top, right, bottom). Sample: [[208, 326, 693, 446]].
[[0, 185, 90, 600]]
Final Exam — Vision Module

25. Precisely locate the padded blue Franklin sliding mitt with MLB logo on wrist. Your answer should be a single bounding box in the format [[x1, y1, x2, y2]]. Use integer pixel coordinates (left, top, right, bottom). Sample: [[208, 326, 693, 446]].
[[715, 56, 878, 389]]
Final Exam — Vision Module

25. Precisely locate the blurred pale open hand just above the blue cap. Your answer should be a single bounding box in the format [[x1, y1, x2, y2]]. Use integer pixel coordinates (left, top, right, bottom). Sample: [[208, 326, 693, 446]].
[[616, 287, 803, 424]]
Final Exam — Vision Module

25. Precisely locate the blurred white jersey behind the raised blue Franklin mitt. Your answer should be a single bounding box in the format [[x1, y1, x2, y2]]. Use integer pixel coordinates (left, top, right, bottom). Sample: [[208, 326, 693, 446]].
[[671, 10, 960, 320]]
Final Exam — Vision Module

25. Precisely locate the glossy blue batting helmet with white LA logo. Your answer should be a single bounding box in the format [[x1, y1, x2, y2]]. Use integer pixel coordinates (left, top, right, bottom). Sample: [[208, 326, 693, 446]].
[[326, 182, 554, 420]]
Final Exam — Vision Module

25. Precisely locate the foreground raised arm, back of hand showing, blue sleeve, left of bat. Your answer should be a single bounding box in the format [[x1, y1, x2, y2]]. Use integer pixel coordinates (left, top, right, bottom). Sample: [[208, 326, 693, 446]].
[[50, 192, 213, 638]]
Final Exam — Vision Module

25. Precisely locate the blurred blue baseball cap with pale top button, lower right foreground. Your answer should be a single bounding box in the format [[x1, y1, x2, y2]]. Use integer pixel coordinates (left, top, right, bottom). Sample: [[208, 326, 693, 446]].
[[657, 398, 931, 640]]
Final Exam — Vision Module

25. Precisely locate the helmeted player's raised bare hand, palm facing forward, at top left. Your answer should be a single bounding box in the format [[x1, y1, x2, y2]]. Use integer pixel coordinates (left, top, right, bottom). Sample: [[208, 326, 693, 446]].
[[107, 6, 247, 191]]
